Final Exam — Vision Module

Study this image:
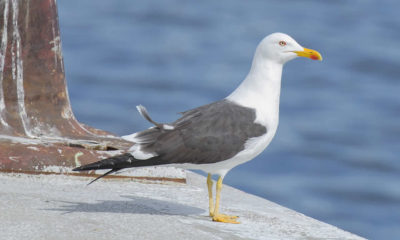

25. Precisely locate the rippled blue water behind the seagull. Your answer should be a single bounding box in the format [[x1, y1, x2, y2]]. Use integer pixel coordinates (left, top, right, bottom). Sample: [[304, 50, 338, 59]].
[[58, 0, 400, 239]]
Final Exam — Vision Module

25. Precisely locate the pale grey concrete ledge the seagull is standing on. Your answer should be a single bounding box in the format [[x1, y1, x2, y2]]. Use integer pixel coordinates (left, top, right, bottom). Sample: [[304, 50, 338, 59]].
[[0, 172, 363, 240]]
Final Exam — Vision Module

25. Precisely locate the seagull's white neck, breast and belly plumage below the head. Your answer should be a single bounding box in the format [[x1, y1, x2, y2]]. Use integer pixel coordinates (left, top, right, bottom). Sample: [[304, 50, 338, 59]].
[[183, 57, 282, 176]]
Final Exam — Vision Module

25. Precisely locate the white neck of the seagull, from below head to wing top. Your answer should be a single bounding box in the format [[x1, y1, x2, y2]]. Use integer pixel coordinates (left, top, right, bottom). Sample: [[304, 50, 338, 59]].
[[227, 56, 283, 115]]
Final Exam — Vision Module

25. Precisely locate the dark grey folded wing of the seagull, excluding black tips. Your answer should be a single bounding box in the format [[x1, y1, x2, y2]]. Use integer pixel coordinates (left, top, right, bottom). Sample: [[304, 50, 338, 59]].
[[134, 100, 266, 164]]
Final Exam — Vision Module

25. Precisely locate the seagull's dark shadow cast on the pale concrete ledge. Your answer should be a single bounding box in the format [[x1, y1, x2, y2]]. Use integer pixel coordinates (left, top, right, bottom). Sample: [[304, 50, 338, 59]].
[[46, 195, 205, 216]]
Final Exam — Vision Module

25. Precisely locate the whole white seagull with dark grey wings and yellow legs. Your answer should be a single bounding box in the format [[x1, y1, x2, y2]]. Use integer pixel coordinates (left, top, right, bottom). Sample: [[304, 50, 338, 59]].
[[73, 33, 322, 223]]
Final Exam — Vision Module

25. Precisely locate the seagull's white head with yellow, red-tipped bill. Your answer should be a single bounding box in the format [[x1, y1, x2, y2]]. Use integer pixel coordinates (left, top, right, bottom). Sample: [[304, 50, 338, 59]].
[[257, 33, 322, 64]]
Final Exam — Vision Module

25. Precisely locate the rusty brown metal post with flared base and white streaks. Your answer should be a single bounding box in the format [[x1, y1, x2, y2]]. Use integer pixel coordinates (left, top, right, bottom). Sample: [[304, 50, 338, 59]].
[[0, 0, 185, 182]]
